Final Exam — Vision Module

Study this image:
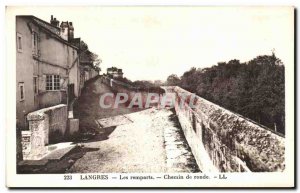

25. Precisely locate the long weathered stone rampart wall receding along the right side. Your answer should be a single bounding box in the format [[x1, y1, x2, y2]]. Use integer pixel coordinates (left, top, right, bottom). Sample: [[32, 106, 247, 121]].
[[166, 87, 285, 172]]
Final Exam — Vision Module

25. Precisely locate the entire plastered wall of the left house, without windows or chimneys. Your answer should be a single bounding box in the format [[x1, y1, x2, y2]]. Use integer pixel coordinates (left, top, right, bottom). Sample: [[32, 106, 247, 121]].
[[16, 16, 80, 128]]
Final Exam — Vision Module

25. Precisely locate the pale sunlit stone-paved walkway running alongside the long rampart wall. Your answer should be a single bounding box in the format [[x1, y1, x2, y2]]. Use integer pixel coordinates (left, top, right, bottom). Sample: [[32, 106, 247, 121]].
[[67, 80, 199, 173]]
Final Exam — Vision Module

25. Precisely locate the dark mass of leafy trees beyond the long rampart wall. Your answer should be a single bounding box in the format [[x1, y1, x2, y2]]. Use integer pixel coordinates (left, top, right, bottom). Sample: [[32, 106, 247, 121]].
[[167, 53, 285, 134]]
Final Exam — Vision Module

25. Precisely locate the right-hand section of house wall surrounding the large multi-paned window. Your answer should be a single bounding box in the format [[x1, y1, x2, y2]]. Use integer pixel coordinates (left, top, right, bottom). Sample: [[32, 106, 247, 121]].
[[39, 25, 79, 102]]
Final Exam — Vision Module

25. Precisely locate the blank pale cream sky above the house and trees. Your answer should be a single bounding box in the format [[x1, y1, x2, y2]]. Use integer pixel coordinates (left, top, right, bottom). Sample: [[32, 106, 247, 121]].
[[8, 6, 294, 80]]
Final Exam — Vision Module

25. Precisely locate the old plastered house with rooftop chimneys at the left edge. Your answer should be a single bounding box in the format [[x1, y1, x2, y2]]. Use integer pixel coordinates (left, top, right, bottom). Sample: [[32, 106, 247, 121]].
[[16, 16, 81, 129]]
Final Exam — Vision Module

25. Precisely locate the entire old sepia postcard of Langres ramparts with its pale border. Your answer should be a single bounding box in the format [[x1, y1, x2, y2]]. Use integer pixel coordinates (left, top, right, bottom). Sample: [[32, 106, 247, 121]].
[[6, 6, 295, 188]]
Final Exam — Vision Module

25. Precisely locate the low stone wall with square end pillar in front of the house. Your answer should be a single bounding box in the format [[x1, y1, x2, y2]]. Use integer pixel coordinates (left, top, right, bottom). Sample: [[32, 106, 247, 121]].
[[22, 104, 68, 160]]
